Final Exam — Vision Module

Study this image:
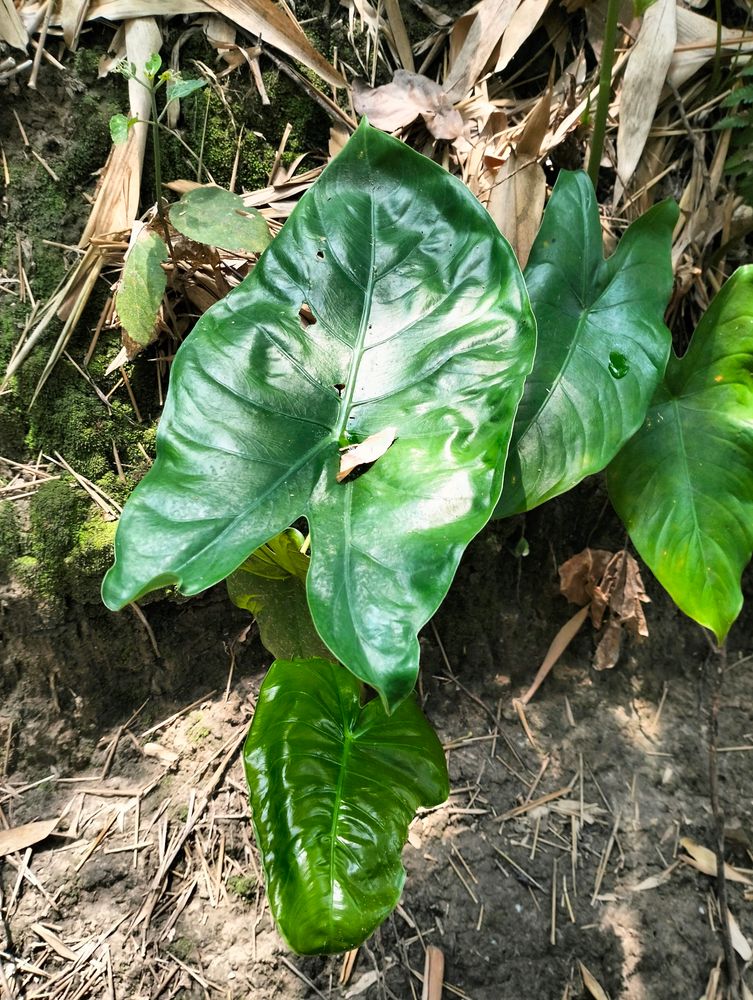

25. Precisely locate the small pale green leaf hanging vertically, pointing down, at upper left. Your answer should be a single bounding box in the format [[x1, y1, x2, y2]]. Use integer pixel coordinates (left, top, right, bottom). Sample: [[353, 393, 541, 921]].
[[115, 229, 168, 347]]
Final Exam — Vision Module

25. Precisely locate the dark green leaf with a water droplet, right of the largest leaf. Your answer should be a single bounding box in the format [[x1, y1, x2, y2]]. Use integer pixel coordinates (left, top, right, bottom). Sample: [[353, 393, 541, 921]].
[[495, 171, 677, 517]]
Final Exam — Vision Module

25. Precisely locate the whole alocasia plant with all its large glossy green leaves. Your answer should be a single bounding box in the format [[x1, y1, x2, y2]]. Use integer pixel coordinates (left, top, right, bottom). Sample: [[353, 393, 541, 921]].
[[103, 113, 753, 952]]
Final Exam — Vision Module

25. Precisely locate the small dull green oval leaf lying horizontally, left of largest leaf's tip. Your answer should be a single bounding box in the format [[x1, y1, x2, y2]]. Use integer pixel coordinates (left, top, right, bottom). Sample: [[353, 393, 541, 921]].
[[170, 187, 270, 253]]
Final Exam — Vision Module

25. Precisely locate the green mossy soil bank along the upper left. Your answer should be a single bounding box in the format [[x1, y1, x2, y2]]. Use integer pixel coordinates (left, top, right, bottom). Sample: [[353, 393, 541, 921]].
[[0, 19, 329, 601]]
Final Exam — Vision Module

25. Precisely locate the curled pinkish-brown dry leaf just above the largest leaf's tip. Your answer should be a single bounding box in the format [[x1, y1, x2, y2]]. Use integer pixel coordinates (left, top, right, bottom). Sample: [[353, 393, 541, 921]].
[[353, 69, 463, 139]]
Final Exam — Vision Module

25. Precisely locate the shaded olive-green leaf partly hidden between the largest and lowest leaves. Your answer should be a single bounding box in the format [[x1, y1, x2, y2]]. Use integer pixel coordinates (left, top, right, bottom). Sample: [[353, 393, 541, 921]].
[[225, 528, 332, 660]]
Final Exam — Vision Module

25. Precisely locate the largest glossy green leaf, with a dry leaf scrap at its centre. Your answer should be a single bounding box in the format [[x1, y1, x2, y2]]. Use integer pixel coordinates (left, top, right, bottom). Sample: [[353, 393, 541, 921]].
[[103, 117, 535, 707]]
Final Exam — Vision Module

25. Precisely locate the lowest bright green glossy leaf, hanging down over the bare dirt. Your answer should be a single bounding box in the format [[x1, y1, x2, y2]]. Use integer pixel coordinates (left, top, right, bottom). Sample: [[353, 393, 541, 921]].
[[244, 660, 449, 954]]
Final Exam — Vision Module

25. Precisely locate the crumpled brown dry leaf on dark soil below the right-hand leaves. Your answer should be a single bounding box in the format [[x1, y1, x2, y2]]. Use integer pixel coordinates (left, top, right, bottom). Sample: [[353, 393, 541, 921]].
[[559, 549, 650, 670]]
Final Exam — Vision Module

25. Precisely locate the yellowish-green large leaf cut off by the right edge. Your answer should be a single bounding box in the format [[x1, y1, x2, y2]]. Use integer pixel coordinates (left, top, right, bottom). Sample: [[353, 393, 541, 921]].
[[607, 266, 753, 642]]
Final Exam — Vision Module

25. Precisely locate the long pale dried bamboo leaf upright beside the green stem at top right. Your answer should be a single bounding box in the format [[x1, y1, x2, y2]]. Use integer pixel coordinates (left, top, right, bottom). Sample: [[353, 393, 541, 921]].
[[617, 0, 677, 187]]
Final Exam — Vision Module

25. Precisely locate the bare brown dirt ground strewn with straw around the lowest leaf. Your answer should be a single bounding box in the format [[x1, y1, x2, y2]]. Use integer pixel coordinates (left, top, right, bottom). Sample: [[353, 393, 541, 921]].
[[0, 482, 753, 1000]]
